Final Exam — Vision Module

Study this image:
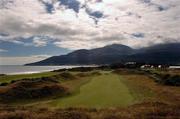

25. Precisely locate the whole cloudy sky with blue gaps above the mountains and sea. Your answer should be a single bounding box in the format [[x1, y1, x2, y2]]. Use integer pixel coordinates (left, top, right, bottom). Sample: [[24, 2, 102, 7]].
[[0, 0, 180, 65]]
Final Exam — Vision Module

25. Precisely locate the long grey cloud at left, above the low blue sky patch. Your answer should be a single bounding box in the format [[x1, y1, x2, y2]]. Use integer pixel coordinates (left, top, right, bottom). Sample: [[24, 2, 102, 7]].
[[0, 16, 81, 37]]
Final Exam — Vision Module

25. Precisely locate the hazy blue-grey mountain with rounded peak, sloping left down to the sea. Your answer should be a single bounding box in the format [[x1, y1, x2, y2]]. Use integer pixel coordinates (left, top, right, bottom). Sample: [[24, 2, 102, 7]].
[[27, 44, 134, 65]]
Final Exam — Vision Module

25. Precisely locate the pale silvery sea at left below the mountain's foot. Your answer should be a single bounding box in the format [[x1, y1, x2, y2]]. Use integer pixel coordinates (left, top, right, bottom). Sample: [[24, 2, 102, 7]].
[[0, 65, 95, 75]]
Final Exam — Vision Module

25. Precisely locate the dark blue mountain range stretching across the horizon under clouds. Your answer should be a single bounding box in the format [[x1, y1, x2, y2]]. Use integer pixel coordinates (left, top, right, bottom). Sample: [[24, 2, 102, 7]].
[[26, 43, 180, 66]]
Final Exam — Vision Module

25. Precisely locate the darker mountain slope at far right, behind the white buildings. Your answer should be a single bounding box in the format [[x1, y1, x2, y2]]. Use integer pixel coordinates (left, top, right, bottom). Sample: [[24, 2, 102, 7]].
[[129, 43, 180, 64]]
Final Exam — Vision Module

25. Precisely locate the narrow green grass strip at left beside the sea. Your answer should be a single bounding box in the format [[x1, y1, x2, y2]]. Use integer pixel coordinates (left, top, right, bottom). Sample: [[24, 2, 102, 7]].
[[0, 72, 57, 83]]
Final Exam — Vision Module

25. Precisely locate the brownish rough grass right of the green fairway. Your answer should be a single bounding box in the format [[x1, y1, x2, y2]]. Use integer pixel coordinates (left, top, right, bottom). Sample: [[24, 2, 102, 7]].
[[116, 71, 180, 105]]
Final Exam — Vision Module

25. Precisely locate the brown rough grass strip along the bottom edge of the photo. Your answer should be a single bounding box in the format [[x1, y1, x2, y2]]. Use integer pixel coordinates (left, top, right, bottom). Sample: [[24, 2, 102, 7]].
[[0, 102, 180, 119]]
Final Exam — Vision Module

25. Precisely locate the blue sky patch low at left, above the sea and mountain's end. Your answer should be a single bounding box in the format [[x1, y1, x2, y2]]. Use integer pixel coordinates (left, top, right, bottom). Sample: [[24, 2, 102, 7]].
[[0, 38, 70, 56]]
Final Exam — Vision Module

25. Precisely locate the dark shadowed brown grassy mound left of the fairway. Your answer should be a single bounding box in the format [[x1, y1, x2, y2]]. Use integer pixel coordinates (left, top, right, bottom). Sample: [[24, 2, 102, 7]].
[[0, 77, 68, 103]]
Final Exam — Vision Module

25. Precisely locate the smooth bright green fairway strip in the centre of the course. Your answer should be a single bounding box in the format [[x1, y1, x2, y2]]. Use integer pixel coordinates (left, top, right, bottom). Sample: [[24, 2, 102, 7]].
[[50, 73, 134, 108]]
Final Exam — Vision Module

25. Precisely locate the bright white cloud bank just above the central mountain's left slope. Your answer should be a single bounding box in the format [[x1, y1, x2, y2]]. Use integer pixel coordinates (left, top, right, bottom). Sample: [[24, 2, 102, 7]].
[[54, 34, 126, 50]]
